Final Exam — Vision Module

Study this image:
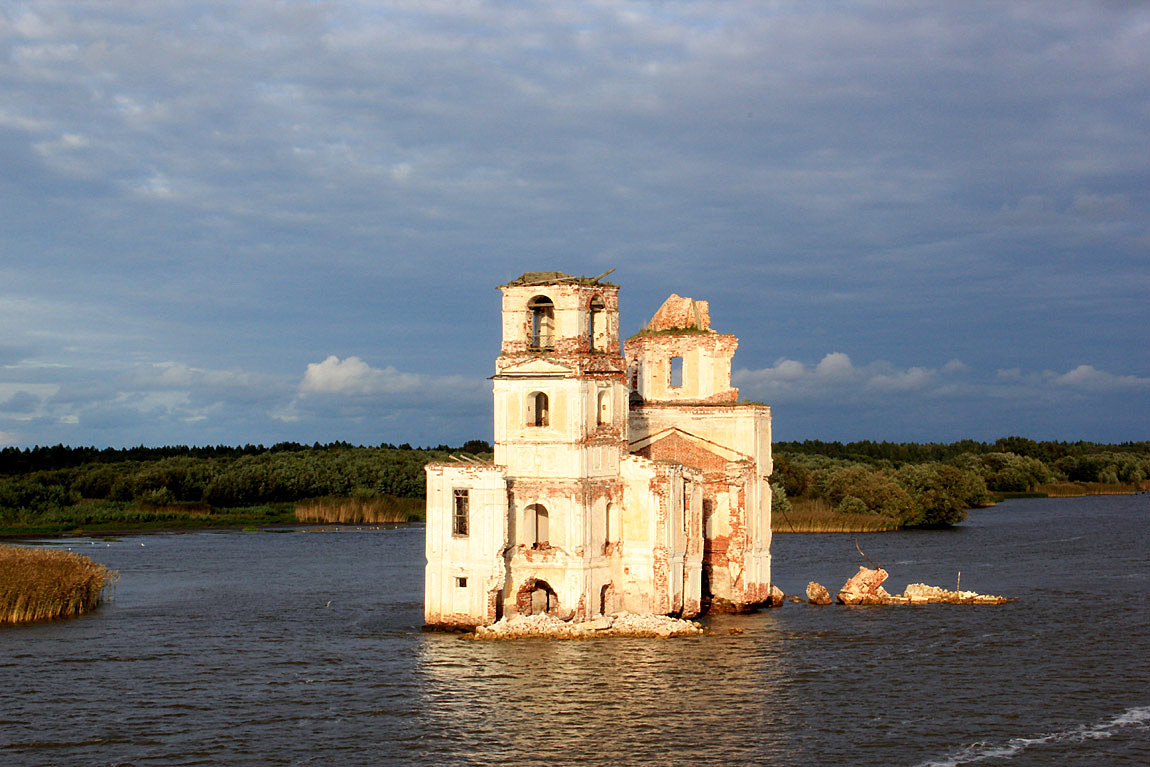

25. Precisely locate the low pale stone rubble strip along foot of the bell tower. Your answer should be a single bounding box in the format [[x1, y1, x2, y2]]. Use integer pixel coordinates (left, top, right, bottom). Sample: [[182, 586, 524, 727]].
[[469, 613, 703, 639]]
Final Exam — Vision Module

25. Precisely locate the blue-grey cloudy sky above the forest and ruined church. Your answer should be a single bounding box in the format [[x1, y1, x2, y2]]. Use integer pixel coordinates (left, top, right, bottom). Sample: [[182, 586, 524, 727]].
[[0, 0, 1150, 447]]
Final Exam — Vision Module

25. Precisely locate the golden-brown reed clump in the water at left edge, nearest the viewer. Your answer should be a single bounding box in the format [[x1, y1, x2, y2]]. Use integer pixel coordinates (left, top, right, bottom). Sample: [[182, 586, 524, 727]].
[[0, 545, 120, 623]]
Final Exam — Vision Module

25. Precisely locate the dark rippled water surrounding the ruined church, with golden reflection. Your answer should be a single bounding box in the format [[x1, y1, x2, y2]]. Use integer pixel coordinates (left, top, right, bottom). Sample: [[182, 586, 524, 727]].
[[0, 496, 1150, 767]]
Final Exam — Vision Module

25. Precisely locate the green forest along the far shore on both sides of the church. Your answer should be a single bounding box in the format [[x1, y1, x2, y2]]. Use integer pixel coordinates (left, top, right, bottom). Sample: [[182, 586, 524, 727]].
[[0, 437, 1150, 532]]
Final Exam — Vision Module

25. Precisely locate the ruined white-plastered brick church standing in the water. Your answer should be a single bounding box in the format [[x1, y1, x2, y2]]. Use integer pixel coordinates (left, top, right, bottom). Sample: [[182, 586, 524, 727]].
[[424, 271, 772, 628]]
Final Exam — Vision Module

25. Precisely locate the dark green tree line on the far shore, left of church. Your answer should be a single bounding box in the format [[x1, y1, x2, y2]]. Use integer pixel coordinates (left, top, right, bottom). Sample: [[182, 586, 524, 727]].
[[0, 440, 491, 527]]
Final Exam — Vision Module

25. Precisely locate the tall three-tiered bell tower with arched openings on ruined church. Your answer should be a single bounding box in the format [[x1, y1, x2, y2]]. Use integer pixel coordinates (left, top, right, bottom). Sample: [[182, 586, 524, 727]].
[[493, 271, 628, 619]]
